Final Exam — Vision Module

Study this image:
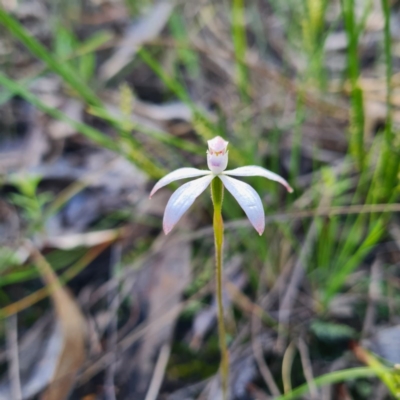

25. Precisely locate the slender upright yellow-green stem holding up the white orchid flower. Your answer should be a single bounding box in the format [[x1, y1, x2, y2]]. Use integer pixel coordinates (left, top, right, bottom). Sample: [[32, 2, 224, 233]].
[[211, 178, 229, 400]]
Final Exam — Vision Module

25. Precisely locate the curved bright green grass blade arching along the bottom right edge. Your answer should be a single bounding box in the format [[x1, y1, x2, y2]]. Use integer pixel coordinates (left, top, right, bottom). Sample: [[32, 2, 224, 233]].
[[275, 367, 390, 400]]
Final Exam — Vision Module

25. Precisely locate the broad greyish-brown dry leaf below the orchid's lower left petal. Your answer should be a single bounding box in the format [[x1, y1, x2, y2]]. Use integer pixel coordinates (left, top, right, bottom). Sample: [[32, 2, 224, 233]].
[[118, 228, 191, 399]]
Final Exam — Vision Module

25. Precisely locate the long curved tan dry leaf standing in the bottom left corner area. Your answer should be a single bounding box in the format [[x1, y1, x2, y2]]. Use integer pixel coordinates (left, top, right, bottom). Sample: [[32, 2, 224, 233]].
[[27, 243, 86, 400]]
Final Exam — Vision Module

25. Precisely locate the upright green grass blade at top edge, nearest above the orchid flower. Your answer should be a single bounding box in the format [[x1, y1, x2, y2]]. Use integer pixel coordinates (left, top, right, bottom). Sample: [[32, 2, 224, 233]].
[[232, 0, 250, 102]]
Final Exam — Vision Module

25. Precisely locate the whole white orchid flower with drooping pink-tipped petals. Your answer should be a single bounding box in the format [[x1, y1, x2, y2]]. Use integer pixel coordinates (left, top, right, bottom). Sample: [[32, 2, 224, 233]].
[[150, 136, 293, 235]]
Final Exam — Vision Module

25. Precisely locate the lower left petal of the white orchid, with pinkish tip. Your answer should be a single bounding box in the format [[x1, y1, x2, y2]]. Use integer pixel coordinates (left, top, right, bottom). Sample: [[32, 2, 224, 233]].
[[163, 175, 214, 235]]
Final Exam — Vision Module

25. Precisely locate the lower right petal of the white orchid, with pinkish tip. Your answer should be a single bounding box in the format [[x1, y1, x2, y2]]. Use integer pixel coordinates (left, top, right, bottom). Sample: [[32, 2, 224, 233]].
[[218, 175, 265, 235]]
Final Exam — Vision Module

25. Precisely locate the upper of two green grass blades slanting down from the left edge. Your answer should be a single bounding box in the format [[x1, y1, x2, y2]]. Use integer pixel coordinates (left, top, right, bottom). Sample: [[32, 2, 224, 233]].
[[0, 8, 101, 106]]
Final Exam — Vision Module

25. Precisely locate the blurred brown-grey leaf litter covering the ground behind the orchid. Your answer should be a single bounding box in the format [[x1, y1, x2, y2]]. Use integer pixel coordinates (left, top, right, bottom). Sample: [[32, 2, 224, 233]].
[[0, 0, 400, 400]]
